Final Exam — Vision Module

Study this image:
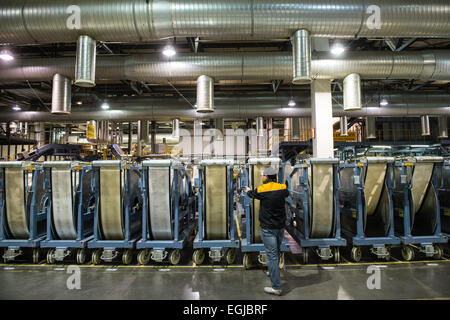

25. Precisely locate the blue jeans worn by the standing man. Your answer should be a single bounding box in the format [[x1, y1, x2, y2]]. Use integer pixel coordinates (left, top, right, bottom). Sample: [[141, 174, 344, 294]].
[[261, 228, 284, 290]]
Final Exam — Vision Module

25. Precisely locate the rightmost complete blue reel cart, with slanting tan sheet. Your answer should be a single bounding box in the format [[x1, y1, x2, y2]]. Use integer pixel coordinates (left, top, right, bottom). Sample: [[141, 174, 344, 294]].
[[392, 156, 447, 261]]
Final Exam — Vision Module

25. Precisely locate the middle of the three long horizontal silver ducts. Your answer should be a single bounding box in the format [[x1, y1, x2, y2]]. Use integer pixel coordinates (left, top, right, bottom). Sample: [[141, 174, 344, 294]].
[[0, 50, 450, 84]]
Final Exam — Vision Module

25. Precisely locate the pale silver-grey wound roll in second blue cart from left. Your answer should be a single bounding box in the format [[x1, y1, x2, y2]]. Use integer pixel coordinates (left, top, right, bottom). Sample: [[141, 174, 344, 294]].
[[44, 161, 77, 240]]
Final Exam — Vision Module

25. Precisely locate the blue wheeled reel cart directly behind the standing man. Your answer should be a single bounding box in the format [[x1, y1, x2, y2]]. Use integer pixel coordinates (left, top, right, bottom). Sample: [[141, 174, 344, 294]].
[[240, 158, 289, 269]]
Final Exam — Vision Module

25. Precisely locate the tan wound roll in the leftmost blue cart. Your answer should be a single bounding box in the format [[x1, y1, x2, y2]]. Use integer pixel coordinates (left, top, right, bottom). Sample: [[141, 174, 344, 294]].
[[5, 163, 30, 239]]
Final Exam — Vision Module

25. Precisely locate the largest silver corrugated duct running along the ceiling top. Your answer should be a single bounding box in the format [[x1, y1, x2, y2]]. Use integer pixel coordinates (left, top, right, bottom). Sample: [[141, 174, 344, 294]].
[[0, 0, 450, 44]]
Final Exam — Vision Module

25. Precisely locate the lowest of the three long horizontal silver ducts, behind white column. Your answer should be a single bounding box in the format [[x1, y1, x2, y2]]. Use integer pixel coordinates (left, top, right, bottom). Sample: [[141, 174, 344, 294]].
[[2, 92, 450, 122]]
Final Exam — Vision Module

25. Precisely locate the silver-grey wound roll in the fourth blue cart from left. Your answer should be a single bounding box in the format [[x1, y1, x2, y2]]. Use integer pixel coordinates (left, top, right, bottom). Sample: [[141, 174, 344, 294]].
[[148, 164, 173, 240]]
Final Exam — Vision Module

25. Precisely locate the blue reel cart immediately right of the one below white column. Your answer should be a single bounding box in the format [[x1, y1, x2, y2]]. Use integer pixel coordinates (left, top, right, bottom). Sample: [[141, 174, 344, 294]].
[[338, 157, 400, 262]]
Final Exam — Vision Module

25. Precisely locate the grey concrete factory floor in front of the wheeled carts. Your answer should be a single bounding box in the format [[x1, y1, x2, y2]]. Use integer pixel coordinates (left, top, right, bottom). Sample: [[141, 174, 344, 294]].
[[0, 260, 450, 300]]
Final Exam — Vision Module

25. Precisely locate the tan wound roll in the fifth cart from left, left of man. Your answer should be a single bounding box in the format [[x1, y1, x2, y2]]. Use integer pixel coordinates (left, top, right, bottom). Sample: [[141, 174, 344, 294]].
[[205, 165, 228, 240]]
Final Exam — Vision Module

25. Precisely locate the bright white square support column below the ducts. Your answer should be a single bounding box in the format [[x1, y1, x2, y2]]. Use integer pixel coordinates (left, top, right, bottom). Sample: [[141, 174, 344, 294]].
[[311, 80, 334, 158]]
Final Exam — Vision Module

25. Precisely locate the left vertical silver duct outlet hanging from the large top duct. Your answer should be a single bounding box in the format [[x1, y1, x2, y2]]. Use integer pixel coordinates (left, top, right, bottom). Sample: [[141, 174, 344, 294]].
[[75, 36, 96, 87]]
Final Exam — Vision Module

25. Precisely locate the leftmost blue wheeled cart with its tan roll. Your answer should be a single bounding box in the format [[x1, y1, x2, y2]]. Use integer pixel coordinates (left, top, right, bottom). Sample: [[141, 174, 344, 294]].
[[0, 161, 49, 263]]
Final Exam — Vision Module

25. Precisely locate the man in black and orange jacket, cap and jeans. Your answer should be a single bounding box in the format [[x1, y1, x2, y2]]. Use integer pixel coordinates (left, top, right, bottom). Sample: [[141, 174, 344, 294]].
[[245, 167, 289, 295]]
